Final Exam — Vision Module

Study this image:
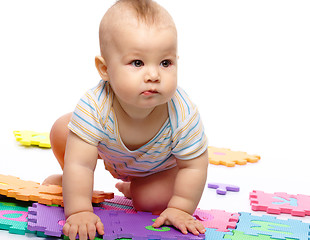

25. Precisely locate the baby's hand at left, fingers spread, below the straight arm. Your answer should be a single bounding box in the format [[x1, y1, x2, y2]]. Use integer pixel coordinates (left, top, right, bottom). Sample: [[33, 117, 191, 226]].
[[63, 212, 104, 240]]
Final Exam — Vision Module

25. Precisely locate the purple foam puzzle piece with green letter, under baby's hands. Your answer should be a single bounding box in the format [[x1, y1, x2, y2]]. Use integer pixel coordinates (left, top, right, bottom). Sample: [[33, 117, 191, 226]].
[[28, 203, 204, 240]]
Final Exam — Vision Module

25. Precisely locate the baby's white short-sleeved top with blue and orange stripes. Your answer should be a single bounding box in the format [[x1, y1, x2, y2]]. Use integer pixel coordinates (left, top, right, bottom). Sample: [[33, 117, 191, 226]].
[[68, 80, 207, 180]]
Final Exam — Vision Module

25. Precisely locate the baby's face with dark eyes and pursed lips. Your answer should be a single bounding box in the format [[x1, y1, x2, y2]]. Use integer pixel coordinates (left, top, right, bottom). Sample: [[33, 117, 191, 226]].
[[104, 20, 177, 108]]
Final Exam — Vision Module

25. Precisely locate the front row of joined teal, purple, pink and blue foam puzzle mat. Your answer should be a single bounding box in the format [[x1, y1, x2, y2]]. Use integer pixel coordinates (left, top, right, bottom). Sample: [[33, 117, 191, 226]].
[[0, 196, 310, 240]]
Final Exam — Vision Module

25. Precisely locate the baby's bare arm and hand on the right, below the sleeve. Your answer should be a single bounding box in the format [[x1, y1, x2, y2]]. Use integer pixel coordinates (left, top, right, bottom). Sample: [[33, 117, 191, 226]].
[[153, 150, 208, 235]]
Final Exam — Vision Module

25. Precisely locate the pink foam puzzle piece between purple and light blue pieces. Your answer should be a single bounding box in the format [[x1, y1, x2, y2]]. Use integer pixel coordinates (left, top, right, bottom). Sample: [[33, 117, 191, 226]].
[[193, 208, 240, 232]]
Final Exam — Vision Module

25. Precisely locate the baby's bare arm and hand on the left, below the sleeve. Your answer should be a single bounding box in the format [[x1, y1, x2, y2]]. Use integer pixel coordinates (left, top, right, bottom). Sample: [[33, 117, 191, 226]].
[[63, 131, 104, 239]]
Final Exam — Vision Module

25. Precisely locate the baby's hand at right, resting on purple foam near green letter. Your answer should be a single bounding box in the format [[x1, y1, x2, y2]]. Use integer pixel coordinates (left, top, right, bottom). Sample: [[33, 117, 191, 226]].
[[152, 208, 206, 235]]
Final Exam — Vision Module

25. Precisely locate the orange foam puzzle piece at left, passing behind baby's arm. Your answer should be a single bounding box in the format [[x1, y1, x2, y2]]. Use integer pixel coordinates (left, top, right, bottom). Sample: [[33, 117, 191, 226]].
[[0, 174, 114, 206]]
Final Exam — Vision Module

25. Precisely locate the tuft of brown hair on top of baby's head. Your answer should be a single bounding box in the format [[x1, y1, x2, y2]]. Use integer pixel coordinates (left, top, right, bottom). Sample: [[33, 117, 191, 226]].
[[115, 0, 159, 25]]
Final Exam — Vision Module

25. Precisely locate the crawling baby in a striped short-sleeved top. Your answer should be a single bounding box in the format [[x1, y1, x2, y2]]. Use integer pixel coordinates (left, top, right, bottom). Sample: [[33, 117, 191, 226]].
[[44, 0, 208, 240]]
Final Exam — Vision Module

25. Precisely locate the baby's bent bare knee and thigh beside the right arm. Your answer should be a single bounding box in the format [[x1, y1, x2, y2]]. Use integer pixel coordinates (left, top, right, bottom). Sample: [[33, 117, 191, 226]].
[[122, 167, 178, 214]]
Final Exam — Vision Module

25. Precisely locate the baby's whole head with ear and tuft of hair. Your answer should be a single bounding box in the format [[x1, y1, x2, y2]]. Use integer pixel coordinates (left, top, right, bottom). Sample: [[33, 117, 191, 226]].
[[96, 0, 178, 108]]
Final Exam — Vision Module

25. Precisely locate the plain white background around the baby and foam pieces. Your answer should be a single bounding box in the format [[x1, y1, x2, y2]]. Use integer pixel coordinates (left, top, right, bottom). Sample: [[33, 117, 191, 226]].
[[0, 0, 310, 239]]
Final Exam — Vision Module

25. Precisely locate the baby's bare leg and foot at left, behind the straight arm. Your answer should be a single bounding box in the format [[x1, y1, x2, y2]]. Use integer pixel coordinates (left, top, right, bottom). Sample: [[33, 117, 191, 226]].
[[43, 113, 72, 185]]
